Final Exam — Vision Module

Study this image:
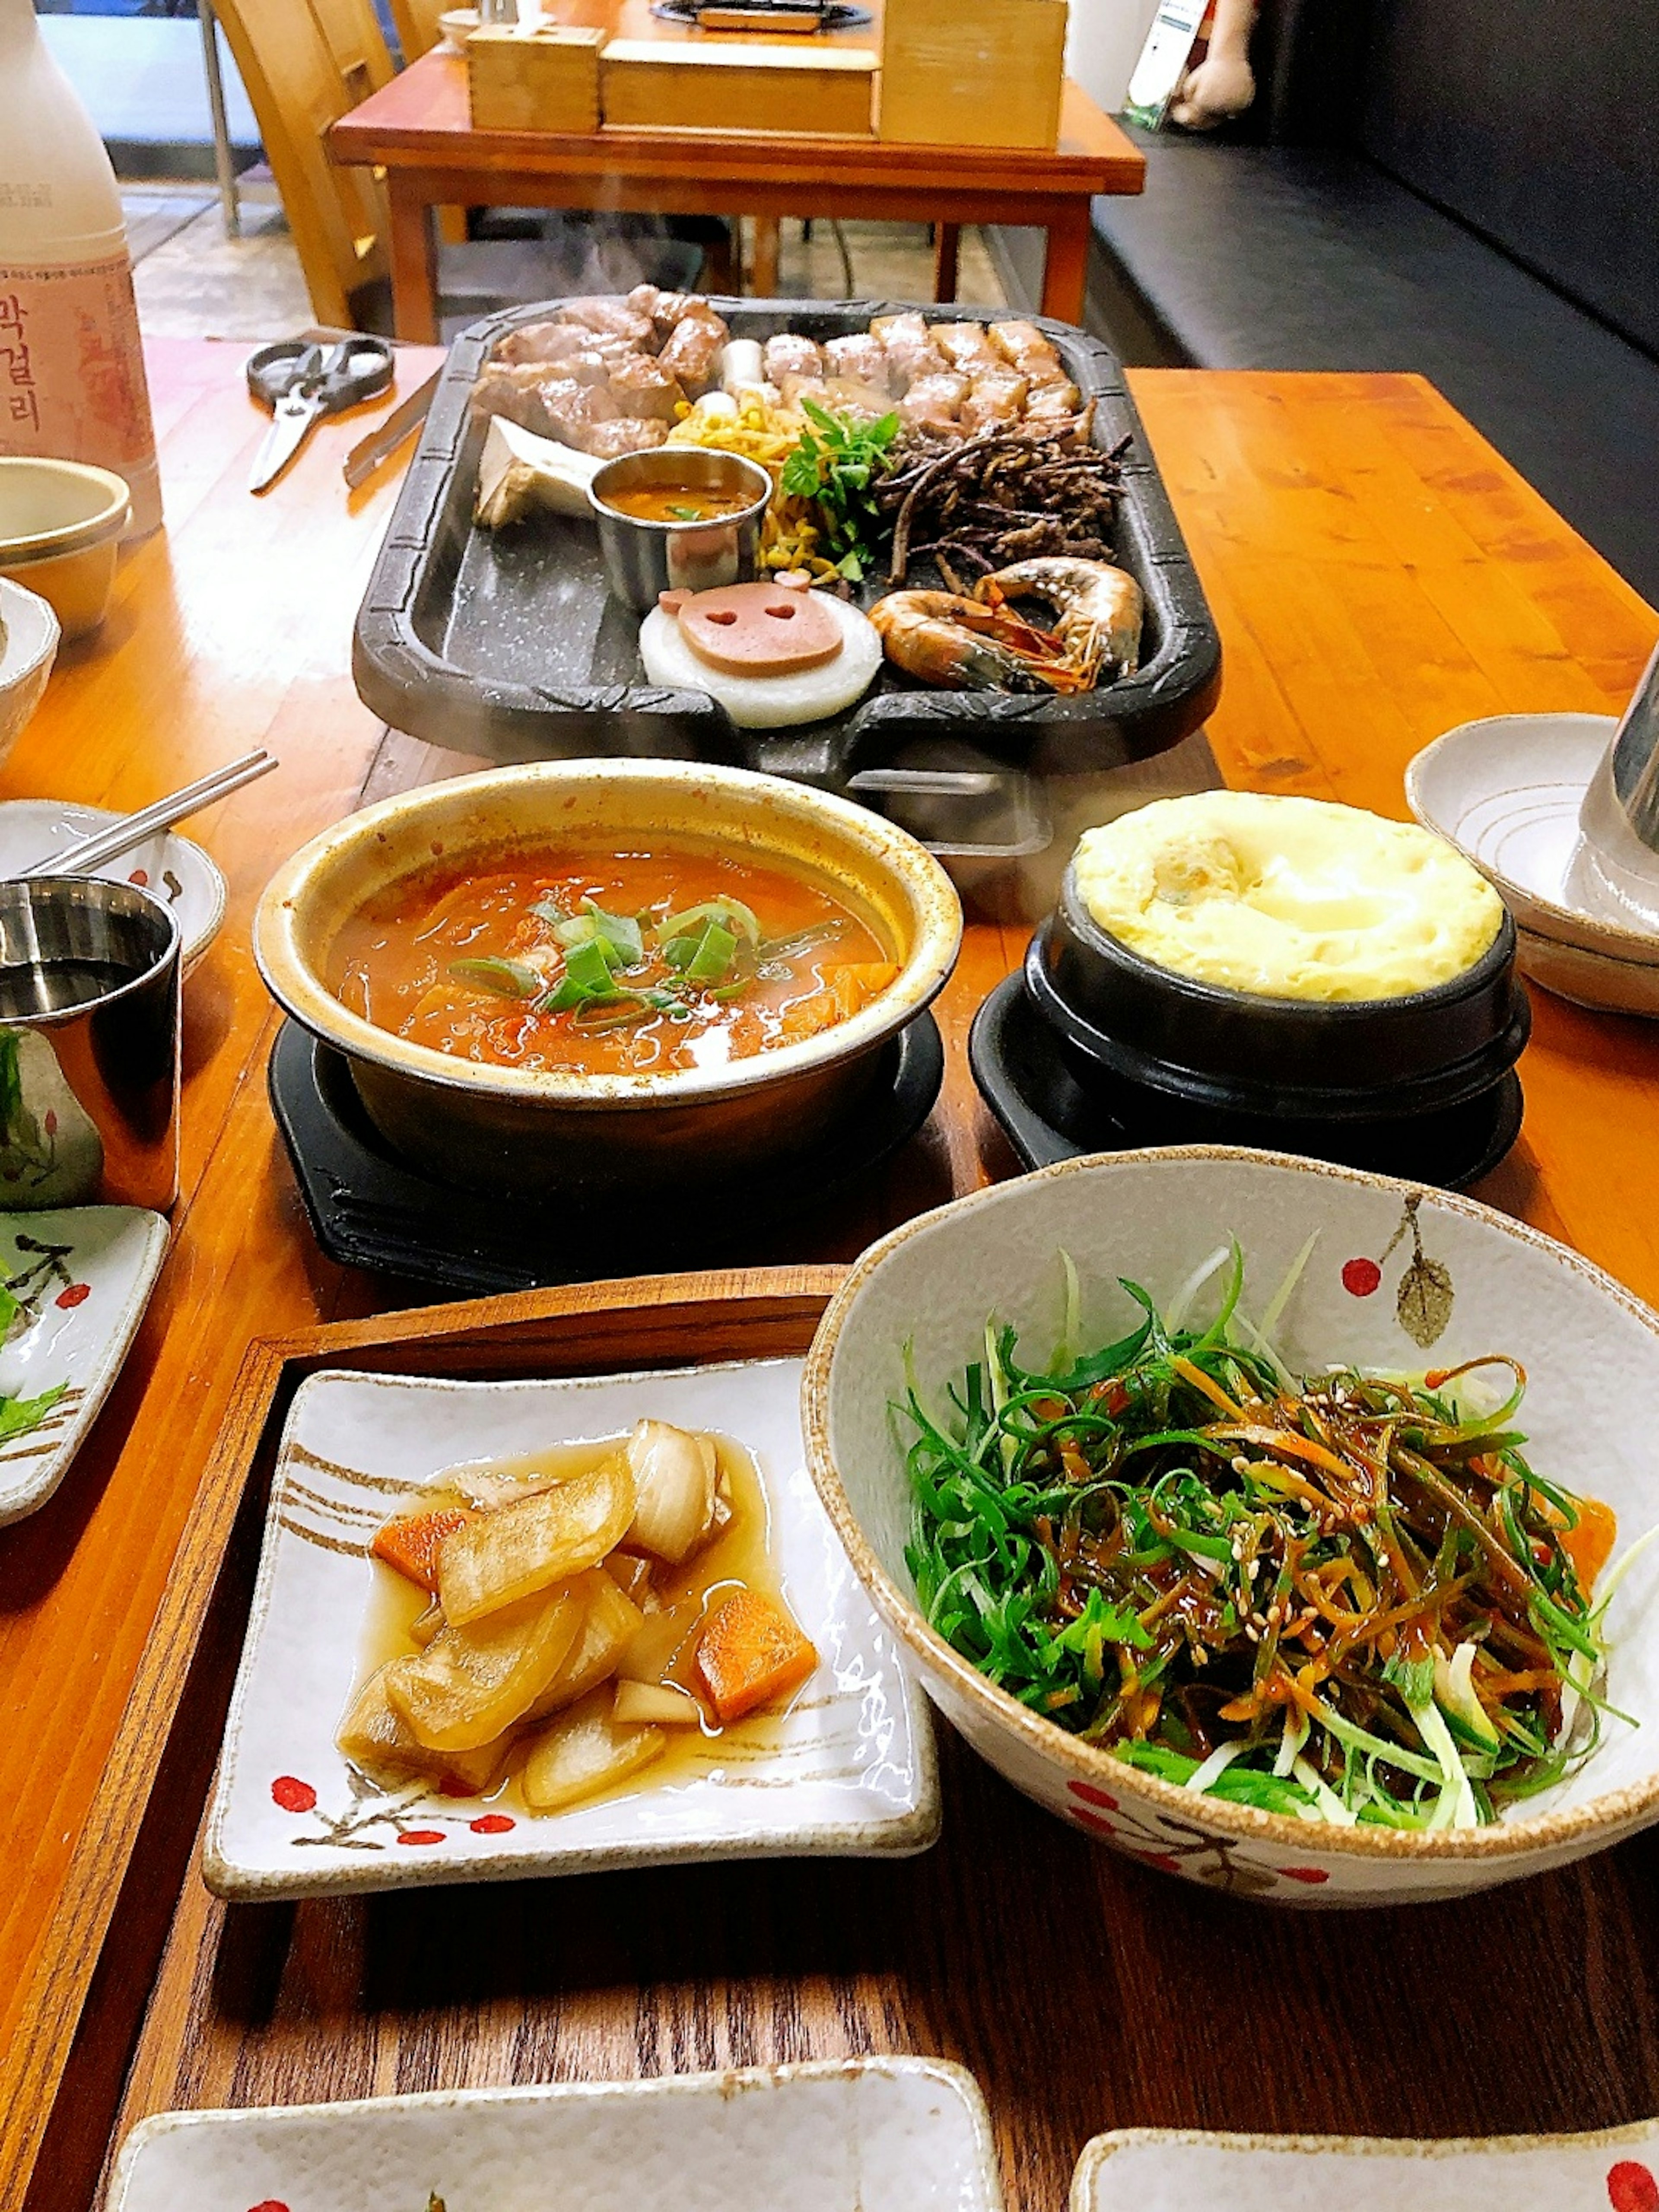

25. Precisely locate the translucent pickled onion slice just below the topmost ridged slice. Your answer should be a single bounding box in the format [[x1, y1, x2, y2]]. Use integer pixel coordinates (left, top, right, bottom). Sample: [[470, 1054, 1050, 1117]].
[[385, 1588, 584, 1752]]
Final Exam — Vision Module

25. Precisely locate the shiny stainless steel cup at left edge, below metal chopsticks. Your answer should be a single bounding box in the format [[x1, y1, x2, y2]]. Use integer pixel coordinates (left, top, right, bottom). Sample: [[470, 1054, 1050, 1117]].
[[0, 876, 179, 1212]]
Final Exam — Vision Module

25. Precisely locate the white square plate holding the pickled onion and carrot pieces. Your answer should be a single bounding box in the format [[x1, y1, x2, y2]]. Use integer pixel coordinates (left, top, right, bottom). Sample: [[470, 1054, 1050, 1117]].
[[203, 1360, 938, 1898]]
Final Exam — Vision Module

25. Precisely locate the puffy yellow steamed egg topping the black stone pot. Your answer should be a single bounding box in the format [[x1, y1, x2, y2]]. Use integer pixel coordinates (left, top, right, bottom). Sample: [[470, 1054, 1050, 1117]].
[[1073, 792, 1504, 1002]]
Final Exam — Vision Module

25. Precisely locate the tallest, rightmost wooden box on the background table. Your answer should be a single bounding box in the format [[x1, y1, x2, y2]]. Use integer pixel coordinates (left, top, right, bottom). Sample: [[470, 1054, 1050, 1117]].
[[876, 0, 1066, 153]]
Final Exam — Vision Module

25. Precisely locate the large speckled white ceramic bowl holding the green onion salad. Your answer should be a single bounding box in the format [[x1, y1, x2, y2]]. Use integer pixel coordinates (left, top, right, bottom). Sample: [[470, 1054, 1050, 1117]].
[[803, 1146, 1659, 1904]]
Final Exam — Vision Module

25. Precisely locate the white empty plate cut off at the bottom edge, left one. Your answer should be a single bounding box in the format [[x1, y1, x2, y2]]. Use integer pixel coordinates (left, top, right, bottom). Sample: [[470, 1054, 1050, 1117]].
[[111, 2057, 1002, 2212]]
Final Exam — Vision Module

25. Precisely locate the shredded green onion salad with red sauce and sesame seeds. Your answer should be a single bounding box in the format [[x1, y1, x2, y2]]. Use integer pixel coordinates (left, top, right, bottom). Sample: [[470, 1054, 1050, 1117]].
[[898, 1243, 1635, 1829]]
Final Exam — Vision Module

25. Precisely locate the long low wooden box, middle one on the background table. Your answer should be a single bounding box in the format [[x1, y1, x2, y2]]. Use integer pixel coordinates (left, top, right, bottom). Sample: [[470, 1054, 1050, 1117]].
[[600, 38, 876, 137]]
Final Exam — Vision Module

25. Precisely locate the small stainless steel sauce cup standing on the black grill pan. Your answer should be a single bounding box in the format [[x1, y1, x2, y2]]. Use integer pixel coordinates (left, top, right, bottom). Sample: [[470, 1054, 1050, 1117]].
[[588, 445, 772, 615]]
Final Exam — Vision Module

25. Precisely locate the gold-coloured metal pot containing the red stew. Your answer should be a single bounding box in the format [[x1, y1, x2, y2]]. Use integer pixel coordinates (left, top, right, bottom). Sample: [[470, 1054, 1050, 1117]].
[[254, 761, 962, 1197]]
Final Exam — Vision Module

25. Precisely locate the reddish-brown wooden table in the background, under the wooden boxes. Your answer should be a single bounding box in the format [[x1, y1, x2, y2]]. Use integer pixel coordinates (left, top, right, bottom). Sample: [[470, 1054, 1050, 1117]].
[[327, 56, 1146, 340]]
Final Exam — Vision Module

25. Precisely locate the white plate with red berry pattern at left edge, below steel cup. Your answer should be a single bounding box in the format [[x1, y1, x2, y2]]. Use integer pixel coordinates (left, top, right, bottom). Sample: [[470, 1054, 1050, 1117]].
[[0, 1205, 168, 1529]]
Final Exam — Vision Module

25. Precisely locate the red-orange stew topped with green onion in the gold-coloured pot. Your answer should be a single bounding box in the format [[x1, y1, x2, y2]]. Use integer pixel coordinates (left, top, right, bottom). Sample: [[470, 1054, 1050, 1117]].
[[330, 845, 898, 1075]]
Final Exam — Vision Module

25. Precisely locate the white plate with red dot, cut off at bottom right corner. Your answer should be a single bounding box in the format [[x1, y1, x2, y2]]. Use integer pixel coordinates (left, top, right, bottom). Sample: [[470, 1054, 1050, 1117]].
[[1079, 2121, 1659, 2212]]
